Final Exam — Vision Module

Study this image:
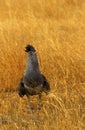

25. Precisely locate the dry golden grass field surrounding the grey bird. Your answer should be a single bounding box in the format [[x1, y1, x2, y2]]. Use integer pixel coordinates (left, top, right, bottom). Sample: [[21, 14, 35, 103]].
[[0, 0, 85, 130]]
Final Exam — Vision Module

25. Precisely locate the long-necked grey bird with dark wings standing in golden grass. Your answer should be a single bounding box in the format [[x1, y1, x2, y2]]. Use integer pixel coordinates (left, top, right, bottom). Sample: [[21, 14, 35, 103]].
[[18, 44, 50, 114]]
